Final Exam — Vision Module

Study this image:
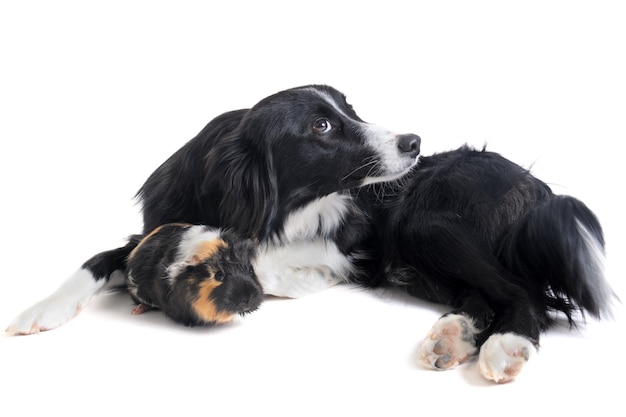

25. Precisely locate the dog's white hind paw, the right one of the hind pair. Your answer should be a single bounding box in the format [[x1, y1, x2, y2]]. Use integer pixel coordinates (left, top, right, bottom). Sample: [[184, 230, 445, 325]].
[[478, 333, 535, 383]]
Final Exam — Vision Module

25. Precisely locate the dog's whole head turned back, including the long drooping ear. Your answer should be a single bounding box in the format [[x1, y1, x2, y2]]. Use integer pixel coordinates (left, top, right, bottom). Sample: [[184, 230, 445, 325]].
[[205, 85, 420, 236]]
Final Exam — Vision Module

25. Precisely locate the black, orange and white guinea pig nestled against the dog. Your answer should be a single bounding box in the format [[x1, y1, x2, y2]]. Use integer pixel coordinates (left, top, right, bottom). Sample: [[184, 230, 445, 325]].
[[126, 223, 263, 326]]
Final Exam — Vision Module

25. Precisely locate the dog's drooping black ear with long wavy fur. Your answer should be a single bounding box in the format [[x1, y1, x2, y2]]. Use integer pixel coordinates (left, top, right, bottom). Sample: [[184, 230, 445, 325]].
[[202, 128, 278, 239]]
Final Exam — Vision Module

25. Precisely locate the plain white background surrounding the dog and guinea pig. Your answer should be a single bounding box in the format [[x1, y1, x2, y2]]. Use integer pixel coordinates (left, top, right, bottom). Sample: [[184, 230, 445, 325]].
[[0, 0, 626, 416]]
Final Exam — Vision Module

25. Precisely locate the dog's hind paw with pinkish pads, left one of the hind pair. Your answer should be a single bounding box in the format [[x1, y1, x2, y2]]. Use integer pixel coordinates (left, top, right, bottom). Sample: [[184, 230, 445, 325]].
[[418, 314, 479, 370]]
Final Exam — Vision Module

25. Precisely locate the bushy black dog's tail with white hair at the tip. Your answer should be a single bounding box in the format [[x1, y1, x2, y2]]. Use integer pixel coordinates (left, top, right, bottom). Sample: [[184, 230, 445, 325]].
[[500, 195, 616, 325]]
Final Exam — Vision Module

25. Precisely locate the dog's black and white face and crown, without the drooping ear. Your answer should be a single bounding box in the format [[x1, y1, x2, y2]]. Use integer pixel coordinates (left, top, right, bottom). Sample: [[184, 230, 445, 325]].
[[242, 85, 420, 187]]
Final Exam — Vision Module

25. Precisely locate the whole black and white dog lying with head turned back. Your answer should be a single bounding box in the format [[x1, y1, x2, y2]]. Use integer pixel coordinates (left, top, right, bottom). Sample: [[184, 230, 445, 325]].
[[8, 86, 613, 382]]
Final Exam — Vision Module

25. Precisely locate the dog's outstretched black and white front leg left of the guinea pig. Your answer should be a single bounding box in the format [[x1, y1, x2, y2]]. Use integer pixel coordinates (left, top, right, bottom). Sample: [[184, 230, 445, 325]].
[[6, 236, 139, 335]]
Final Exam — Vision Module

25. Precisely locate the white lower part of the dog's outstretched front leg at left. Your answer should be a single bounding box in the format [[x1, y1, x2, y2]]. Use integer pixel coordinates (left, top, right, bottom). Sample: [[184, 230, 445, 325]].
[[6, 269, 106, 334]]
